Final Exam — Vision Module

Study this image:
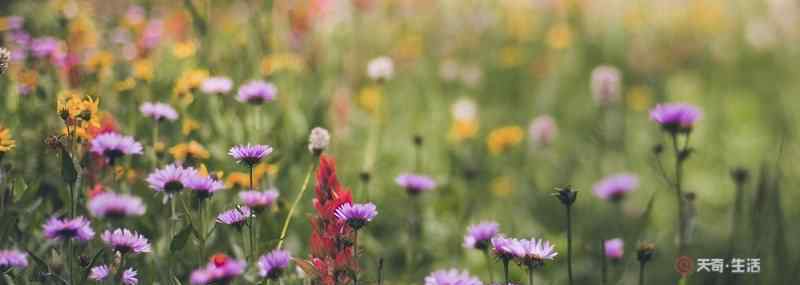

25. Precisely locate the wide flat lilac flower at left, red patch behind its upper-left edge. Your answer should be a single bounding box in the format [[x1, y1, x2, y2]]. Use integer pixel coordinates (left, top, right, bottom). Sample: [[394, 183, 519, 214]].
[[86, 192, 145, 218]]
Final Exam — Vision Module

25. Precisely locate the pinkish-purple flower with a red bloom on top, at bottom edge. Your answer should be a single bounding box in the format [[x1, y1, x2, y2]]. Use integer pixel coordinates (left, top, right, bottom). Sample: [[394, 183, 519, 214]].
[[189, 254, 247, 285]]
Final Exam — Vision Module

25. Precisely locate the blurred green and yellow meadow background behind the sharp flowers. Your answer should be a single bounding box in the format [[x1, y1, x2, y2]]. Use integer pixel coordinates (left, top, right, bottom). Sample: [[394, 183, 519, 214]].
[[0, 0, 800, 284]]
